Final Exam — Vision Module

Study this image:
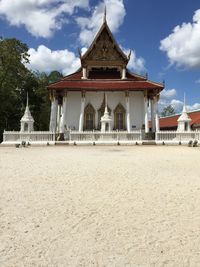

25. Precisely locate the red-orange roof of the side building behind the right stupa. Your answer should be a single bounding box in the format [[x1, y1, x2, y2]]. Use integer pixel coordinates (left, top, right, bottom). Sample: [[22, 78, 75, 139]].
[[160, 110, 200, 129]]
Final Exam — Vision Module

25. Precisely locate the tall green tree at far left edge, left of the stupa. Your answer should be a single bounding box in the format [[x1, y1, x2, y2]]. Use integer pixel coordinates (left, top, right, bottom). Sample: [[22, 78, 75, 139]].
[[0, 38, 29, 139]]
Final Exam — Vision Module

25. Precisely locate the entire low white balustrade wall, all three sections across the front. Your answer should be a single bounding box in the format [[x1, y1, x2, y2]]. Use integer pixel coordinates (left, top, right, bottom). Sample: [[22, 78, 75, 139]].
[[2, 130, 200, 144]]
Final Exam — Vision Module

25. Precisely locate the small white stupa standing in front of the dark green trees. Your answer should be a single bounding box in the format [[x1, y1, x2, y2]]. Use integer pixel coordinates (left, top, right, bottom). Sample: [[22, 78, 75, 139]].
[[20, 93, 34, 132]]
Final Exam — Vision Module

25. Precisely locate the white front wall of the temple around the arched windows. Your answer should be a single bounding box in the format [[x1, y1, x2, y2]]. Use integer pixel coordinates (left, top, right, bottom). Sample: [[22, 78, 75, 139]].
[[65, 92, 144, 130]]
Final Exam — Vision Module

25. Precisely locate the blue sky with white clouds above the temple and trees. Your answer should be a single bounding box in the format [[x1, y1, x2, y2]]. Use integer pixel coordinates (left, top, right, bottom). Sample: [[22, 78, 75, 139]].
[[0, 0, 200, 112]]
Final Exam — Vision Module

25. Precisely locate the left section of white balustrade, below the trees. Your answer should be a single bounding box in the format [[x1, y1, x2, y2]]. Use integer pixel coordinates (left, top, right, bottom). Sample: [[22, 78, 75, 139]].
[[3, 131, 55, 142]]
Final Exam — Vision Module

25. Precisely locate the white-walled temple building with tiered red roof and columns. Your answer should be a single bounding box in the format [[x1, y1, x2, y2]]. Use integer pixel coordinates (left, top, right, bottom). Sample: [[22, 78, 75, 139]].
[[48, 13, 164, 140]]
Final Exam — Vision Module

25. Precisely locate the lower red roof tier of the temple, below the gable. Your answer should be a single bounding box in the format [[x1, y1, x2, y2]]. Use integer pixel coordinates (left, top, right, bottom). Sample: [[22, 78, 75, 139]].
[[48, 70, 164, 91]]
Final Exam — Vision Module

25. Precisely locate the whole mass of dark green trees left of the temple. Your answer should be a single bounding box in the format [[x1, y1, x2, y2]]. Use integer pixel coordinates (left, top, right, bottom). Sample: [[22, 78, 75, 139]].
[[0, 39, 63, 142]]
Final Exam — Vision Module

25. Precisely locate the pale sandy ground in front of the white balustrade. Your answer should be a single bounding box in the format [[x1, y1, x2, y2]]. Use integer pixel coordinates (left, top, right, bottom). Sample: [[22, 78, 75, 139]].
[[0, 146, 200, 267]]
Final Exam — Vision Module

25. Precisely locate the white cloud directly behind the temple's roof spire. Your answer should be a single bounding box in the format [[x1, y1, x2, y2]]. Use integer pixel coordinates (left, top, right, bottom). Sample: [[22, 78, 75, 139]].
[[76, 0, 126, 46]]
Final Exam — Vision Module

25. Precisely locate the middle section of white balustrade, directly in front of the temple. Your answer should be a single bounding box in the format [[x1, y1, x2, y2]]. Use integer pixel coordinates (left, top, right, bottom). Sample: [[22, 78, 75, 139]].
[[70, 130, 142, 141]]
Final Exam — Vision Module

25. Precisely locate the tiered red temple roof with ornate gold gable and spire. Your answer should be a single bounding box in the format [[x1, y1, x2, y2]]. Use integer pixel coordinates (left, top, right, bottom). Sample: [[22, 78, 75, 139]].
[[48, 16, 164, 95]]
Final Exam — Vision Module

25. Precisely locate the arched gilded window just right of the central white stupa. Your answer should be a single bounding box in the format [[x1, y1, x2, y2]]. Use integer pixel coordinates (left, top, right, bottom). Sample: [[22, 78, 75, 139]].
[[114, 103, 126, 130]]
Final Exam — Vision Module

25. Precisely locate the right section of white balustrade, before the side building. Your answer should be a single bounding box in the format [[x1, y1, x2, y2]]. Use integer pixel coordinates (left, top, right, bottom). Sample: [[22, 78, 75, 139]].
[[156, 130, 200, 142]]
